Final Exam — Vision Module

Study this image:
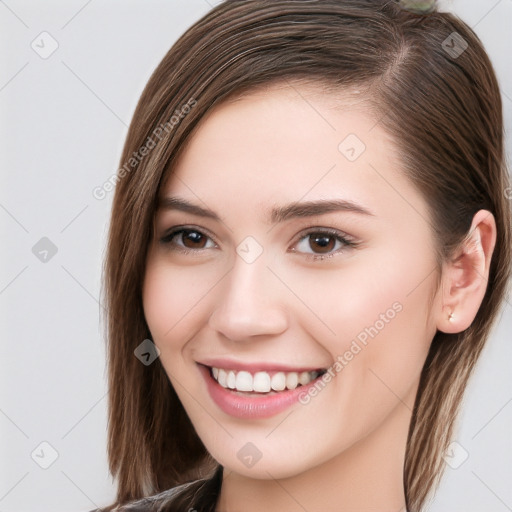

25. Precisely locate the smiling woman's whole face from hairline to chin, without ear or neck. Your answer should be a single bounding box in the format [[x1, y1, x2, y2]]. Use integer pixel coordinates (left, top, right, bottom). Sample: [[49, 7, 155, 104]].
[[143, 84, 440, 478]]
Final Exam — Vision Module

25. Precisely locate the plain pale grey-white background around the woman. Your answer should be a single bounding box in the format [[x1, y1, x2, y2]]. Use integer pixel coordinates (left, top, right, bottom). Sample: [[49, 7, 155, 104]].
[[0, 0, 512, 512]]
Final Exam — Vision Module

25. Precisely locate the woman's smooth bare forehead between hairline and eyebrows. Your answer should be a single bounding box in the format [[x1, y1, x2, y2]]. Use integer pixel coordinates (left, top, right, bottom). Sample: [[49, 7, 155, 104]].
[[161, 84, 424, 222]]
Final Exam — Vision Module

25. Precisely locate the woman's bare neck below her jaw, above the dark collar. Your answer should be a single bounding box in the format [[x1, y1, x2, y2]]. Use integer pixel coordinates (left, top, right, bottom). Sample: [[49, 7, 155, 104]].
[[217, 388, 414, 512]]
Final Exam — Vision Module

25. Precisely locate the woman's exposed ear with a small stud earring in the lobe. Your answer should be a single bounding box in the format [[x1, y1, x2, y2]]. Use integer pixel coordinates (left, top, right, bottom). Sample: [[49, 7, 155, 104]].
[[437, 210, 496, 333]]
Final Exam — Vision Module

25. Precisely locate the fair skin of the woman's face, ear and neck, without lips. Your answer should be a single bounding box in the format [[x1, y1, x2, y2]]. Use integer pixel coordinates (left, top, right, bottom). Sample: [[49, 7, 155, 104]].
[[143, 84, 496, 512]]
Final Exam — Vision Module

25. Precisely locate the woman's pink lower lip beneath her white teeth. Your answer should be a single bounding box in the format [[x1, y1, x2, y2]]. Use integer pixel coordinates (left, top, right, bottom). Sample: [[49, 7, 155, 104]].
[[198, 364, 321, 419]]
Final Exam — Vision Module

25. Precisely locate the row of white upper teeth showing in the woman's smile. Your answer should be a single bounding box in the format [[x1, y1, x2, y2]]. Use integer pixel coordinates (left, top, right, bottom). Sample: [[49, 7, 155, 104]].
[[212, 368, 320, 393]]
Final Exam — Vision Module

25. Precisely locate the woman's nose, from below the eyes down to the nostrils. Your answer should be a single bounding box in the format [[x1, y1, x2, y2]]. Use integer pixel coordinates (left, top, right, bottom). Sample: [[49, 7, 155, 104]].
[[209, 256, 288, 341]]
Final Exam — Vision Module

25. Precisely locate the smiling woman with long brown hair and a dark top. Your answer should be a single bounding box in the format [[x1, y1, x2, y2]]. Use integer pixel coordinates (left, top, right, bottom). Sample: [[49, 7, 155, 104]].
[[95, 0, 511, 512]]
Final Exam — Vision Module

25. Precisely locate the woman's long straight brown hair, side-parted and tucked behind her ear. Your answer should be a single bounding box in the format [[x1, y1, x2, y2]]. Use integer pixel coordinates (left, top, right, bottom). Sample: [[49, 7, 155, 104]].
[[104, 0, 511, 512]]
